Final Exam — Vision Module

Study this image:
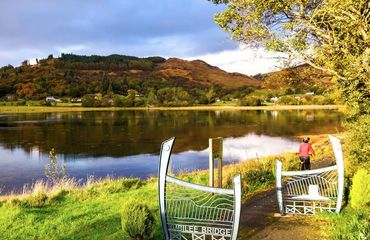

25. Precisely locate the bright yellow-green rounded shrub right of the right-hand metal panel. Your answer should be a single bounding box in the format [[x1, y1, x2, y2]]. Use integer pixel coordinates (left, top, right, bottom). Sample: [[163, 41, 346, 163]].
[[350, 169, 370, 209]]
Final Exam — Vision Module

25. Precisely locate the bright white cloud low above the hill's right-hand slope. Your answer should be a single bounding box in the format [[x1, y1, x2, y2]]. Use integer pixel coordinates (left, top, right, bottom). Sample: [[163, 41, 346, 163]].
[[185, 45, 284, 75]]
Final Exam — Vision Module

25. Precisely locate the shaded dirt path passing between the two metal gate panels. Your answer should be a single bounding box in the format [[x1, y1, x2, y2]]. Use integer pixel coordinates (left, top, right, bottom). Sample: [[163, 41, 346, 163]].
[[238, 190, 327, 240]]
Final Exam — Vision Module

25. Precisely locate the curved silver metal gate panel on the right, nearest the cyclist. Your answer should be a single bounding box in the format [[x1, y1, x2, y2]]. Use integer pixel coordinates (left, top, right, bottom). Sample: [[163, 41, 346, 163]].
[[276, 135, 344, 215]]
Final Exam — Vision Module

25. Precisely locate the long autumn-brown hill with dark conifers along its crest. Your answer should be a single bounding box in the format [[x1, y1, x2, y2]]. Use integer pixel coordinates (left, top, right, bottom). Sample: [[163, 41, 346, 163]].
[[0, 54, 261, 100]]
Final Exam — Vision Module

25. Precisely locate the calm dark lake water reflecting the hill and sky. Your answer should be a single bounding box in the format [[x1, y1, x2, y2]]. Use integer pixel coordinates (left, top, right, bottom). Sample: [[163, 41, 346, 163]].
[[0, 110, 341, 193]]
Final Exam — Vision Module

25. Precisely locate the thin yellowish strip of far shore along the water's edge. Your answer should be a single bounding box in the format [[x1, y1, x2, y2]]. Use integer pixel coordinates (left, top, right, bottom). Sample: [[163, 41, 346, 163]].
[[0, 105, 343, 114]]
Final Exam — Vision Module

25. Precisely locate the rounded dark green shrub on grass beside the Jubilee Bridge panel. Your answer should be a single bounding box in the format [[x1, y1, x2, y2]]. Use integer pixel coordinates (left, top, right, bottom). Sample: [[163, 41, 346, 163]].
[[121, 202, 154, 240]]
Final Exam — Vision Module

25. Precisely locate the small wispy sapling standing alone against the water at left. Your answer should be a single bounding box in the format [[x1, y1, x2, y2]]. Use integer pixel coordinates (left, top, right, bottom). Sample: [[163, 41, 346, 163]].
[[45, 148, 67, 185]]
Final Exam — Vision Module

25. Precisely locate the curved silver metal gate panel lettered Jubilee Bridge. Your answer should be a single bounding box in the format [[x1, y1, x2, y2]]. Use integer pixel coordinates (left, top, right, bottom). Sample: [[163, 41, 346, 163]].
[[158, 138, 241, 240]]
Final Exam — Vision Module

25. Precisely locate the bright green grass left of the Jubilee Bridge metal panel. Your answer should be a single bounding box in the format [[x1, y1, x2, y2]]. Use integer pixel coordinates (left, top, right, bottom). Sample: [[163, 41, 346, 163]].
[[0, 179, 162, 239]]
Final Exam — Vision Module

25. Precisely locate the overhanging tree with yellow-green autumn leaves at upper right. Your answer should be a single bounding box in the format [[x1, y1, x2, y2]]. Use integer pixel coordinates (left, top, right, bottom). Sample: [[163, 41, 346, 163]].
[[212, 0, 370, 116]]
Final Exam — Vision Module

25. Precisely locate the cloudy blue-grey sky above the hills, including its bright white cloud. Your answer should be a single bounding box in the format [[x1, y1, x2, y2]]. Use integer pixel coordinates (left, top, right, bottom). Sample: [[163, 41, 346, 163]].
[[0, 0, 279, 75]]
